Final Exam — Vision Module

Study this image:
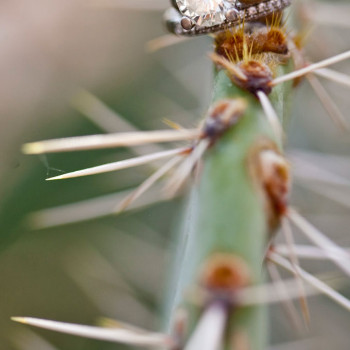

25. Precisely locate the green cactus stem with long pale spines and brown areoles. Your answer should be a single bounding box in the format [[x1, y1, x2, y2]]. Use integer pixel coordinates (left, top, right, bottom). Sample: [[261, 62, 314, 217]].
[[8, 2, 350, 350]]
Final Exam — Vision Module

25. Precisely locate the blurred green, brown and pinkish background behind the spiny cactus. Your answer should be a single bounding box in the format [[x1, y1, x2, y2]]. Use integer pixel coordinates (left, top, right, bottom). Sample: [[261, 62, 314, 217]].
[[0, 0, 350, 350]]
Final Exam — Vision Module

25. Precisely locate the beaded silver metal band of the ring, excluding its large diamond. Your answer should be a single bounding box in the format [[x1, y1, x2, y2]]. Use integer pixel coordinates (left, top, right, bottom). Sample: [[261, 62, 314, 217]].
[[164, 0, 291, 36]]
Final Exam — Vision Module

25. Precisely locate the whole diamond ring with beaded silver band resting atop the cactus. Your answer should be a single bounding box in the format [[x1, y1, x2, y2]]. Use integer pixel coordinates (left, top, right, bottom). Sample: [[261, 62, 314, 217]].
[[164, 0, 291, 36]]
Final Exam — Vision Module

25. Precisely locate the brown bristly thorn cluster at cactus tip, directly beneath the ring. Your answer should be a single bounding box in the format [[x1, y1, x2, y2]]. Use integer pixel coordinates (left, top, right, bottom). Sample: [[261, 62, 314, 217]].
[[211, 14, 290, 96]]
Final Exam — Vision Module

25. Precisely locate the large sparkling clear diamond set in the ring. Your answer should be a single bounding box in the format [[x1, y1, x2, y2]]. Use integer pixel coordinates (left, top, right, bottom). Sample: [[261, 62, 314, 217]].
[[176, 0, 233, 27]]
